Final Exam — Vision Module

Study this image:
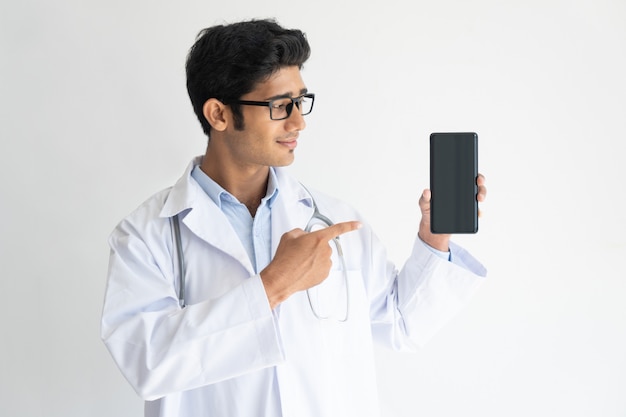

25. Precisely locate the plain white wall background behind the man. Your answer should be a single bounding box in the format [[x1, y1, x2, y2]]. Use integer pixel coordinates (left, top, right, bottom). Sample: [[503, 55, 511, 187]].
[[0, 0, 626, 417]]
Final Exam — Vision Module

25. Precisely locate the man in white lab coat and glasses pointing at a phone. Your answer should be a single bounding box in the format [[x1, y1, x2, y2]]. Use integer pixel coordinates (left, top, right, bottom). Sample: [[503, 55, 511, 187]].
[[102, 20, 486, 417]]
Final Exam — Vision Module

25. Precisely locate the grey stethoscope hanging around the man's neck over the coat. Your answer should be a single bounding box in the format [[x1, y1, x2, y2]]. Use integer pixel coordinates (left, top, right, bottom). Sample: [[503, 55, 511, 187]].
[[171, 186, 350, 322]]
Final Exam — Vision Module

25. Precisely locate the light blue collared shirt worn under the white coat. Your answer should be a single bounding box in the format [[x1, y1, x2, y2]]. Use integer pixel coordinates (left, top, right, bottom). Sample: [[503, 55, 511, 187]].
[[191, 165, 278, 273]]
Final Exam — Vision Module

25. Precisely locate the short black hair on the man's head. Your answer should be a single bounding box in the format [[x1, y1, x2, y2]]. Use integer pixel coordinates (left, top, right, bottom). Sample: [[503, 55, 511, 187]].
[[186, 19, 311, 136]]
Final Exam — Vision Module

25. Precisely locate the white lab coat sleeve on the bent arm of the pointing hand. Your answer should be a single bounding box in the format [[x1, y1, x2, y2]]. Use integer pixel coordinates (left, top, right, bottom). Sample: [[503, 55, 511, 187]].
[[101, 216, 284, 400]]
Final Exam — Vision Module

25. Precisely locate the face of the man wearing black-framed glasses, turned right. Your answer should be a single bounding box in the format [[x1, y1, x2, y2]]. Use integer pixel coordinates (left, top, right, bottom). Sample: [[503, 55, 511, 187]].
[[223, 67, 307, 167]]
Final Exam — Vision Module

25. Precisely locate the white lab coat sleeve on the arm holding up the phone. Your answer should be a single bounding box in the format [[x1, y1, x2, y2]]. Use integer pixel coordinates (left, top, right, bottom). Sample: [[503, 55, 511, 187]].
[[372, 232, 486, 351]]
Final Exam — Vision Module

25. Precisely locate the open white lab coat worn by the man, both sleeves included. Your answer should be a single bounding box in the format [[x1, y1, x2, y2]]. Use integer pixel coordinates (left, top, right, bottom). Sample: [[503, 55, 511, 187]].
[[101, 159, 485, 417]]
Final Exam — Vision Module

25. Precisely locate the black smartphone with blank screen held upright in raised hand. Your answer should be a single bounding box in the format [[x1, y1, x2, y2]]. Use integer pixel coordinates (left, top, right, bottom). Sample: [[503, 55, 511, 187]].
[[430, 132, 478, 233]]
